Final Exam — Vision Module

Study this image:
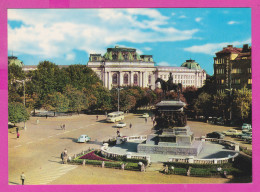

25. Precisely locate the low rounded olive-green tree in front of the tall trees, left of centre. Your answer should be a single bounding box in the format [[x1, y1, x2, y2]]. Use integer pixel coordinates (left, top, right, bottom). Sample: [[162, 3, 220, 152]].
[[43, 92, 69, 116]]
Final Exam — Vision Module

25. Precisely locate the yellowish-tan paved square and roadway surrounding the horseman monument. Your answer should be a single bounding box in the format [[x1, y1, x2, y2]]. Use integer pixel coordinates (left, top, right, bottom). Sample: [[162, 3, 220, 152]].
[[8, 114, 250, 185]]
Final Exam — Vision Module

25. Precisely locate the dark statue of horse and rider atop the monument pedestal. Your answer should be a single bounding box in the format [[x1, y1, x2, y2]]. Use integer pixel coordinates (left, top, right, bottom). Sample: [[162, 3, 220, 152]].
[[155, 73, 182, 100]]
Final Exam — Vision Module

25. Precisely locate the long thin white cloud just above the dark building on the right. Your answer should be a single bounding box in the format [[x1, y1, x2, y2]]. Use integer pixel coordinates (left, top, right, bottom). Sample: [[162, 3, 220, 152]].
[[184, 38, 251, 55]]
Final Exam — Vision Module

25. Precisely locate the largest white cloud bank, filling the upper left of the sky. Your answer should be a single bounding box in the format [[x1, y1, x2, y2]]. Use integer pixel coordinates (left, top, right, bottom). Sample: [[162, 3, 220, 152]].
[[8, 9, 198, 59]]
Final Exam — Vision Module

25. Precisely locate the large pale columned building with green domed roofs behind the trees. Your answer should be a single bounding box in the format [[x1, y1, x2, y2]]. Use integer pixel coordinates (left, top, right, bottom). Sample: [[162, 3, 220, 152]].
[[87, 46, 206, 89]]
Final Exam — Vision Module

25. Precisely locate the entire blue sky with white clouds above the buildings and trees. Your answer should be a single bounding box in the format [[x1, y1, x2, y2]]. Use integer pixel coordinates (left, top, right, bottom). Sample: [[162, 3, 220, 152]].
[[8, 8, 251, 75]]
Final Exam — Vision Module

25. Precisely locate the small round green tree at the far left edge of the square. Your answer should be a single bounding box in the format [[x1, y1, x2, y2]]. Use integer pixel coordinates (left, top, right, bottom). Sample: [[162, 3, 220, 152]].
[[8, 102, 30, 124]]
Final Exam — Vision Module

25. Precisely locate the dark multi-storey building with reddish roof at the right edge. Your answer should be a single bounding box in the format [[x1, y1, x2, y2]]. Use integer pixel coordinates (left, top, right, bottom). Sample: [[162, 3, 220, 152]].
[[214, 44, 252, 92]]
